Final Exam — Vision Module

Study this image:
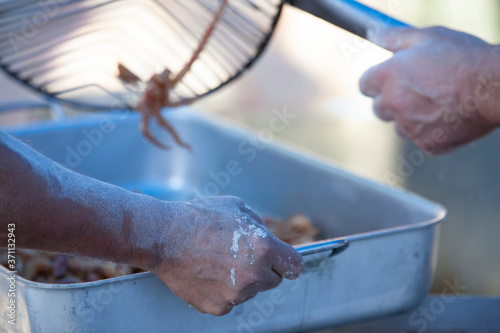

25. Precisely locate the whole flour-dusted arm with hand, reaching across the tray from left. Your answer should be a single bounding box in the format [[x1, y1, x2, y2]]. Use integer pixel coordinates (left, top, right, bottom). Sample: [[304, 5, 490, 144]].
[[0, 131, 302, 315]]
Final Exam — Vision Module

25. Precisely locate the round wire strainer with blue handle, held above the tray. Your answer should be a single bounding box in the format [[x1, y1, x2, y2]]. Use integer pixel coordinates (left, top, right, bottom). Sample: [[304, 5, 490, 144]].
[[0, 0, 406, 109]]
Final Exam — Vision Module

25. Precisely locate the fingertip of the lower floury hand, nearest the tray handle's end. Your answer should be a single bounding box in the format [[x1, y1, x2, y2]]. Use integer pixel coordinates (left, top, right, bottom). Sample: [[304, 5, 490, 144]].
[[271, 239, 303, 280]]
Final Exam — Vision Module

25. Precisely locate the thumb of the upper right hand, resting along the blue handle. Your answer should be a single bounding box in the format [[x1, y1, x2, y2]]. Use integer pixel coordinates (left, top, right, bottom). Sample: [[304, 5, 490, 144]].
[[367, 27, 426, 52]]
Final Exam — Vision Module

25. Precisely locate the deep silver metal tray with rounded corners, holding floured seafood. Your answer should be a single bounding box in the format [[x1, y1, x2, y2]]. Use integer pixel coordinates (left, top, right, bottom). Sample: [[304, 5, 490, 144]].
[[0, 109, 446, 333]]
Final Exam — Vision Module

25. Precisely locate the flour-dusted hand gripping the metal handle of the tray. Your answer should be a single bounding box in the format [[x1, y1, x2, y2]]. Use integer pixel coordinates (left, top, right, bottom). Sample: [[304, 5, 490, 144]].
[[153, 197, 302, 315]]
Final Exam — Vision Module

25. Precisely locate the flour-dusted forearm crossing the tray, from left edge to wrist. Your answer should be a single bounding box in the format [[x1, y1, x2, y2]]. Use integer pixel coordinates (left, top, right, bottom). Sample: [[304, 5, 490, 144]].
[[0, 133, 171, 269]]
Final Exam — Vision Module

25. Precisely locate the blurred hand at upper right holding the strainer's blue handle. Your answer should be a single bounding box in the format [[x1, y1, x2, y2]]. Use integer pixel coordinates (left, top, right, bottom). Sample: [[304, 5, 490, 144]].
[[360, 27, 500, 154]]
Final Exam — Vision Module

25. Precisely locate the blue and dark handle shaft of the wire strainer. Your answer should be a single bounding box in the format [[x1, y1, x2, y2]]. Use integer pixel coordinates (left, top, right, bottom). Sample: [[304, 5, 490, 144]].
[[290, 0, 410, 38]]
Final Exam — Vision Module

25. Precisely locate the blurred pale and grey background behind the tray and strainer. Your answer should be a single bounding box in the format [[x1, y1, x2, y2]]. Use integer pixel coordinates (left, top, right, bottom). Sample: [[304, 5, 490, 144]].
[[0, 0, 500, 296]]
